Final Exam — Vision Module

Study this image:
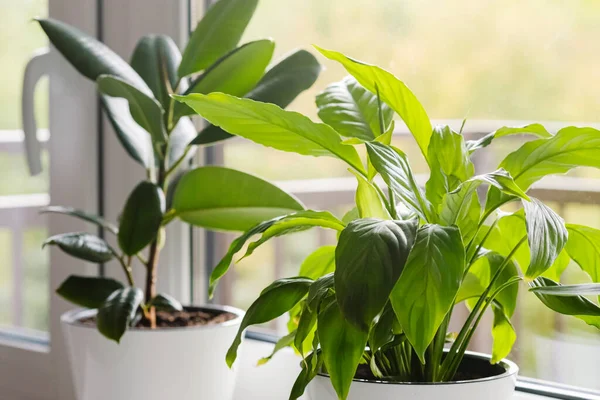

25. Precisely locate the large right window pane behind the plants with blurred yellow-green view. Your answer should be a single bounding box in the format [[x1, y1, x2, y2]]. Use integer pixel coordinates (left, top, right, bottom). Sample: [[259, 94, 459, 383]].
[[200, 0, 600, 390]]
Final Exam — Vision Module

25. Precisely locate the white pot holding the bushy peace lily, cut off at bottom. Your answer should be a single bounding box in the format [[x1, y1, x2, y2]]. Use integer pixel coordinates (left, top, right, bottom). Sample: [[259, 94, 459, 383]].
[[308, 352, 519, 400]]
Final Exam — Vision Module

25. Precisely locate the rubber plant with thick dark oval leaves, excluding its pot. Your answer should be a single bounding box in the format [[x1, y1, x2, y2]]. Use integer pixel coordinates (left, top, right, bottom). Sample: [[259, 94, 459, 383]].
[[38, 0, 321, 341]]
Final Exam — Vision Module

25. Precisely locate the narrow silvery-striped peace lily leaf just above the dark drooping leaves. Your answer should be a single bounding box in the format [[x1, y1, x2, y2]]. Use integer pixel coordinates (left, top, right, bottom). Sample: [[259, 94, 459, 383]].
[[366, 142, 436, 221]]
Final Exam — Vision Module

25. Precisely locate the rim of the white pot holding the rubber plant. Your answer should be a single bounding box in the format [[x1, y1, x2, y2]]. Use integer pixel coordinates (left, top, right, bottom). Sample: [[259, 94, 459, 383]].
[[60, 304, 245, 334]]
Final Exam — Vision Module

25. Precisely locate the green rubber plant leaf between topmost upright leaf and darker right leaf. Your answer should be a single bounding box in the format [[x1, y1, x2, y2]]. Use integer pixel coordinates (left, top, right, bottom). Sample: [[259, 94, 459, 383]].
[[175, 39, 275, 119]]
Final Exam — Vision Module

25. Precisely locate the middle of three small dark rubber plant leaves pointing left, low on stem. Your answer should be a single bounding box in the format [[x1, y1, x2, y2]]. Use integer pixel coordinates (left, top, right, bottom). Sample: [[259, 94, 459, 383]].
[[42, 232, 114, 263]]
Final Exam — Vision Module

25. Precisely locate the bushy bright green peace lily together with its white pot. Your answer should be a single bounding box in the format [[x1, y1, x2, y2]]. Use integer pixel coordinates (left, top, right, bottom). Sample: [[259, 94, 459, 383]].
[[176, 45, 600, 400]]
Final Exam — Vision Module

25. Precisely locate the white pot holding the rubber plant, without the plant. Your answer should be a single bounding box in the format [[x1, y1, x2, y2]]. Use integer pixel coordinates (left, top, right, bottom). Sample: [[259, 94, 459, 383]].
[[61, 305, 244, 400]]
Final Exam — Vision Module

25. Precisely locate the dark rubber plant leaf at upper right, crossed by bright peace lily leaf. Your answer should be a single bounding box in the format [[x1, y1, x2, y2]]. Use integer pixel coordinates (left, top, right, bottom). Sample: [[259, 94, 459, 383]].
[[194, 50, 322, 144]]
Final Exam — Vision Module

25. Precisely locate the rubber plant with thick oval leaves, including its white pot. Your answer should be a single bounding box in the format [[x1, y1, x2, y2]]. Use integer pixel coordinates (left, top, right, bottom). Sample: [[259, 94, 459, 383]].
[[38, 0, 321, 400]]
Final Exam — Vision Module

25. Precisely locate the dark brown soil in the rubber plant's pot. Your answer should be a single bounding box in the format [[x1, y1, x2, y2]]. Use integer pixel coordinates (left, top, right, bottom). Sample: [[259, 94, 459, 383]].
[[79, 307, 236, 329]]
